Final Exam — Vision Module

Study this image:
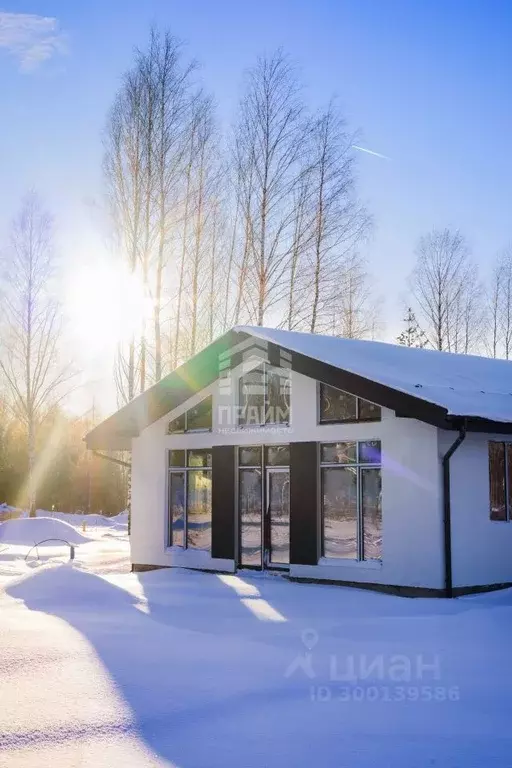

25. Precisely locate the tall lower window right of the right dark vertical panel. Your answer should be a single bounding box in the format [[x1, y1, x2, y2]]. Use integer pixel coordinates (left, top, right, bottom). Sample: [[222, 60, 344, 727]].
[[320, 440, 382, 560]]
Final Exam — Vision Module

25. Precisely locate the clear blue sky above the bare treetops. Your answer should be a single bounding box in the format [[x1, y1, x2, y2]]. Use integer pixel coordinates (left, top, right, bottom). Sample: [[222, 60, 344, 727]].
[[0, 0, 512, 414]]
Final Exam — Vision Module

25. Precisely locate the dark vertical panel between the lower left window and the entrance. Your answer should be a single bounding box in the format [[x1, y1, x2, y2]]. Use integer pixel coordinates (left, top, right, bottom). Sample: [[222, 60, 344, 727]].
[[212, 445, 236, 560]]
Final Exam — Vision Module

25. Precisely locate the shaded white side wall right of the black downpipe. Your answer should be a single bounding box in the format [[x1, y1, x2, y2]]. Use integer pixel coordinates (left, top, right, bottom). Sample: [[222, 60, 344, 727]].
[[439, 432, 512, 587]]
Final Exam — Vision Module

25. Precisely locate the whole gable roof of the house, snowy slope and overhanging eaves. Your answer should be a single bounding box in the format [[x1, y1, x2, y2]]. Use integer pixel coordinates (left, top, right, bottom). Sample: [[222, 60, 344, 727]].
[[86, 326, 512, 450]]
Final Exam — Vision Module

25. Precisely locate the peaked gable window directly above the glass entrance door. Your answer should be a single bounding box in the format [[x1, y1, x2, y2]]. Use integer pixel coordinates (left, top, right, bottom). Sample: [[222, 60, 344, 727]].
[[238, 363, 290, 427]]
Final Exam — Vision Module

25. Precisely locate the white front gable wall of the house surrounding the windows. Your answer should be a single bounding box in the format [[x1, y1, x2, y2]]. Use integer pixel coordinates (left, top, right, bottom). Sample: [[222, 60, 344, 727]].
[[131, 368, 443, 589]]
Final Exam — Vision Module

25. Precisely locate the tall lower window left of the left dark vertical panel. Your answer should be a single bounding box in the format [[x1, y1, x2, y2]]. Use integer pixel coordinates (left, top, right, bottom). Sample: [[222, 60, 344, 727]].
[[169, 449, 212, 550]]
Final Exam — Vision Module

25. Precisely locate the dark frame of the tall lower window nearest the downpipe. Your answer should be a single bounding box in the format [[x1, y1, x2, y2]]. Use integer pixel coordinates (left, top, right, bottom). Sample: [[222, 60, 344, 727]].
[[318, 438, 382, 563]]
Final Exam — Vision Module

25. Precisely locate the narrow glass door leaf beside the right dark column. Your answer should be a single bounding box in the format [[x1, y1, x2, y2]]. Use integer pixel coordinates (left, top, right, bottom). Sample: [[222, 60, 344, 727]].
[[263, 467, 290, 568]]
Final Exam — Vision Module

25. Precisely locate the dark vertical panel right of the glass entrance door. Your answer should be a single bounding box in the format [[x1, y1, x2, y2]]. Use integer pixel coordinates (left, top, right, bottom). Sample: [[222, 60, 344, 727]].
[[290, 443, 319, 565]]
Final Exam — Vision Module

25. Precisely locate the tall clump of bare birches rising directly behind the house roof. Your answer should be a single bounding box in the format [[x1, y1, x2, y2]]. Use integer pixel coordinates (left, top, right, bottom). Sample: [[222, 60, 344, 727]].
[[105, 38, 375, 378]]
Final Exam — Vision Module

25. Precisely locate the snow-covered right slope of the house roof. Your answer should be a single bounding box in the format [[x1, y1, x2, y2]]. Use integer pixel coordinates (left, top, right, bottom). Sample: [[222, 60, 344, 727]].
[[235, 326, 512, 423]]
